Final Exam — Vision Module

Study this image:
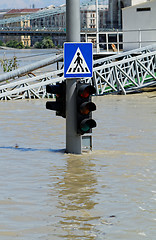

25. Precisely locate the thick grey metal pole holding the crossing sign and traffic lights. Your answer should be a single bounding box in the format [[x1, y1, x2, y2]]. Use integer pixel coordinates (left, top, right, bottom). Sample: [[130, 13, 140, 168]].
[[66, 0, 82, 154]]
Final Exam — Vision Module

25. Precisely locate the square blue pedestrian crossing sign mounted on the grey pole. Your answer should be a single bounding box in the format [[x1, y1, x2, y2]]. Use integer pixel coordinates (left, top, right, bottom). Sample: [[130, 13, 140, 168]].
[[64, 42, 93, 78]]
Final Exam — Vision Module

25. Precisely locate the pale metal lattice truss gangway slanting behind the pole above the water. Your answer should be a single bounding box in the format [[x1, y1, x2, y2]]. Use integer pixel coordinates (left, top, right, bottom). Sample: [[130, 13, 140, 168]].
[[0, 45, 156, 100]]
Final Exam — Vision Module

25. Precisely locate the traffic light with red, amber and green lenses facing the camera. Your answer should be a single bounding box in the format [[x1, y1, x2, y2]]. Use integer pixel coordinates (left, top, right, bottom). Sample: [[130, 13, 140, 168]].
[[77, 83, 96, 135]]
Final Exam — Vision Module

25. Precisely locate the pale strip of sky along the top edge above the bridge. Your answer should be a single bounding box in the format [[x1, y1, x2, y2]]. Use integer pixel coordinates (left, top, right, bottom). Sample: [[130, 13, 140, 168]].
[[0, 0, 106, 9]]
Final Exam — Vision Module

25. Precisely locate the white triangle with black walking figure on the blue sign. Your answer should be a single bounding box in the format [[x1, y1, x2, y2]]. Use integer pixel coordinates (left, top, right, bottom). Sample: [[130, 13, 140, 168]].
[[66, 48, 90, 74]]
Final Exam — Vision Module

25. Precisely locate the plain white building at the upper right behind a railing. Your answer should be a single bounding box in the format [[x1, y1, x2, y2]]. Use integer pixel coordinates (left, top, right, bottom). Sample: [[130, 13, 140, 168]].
[[122, 0, 156, 51]]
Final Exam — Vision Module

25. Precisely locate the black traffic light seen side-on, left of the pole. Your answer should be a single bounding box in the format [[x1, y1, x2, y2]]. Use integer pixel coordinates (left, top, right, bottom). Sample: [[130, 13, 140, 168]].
[[46, 82, 66, 118]]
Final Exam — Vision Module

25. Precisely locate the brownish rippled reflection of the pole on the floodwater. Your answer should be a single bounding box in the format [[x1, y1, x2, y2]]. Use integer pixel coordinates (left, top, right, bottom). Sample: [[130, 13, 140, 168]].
[[56, 156, 99, 239]]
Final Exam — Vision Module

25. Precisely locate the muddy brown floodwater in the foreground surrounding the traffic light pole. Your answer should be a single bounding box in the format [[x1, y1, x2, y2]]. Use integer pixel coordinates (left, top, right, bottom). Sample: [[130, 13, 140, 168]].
[[0, 48, 156, 240]]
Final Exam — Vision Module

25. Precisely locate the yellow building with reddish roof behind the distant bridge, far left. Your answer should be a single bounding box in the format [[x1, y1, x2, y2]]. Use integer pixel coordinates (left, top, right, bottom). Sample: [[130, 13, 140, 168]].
[[3, 8, 40, 46]]
